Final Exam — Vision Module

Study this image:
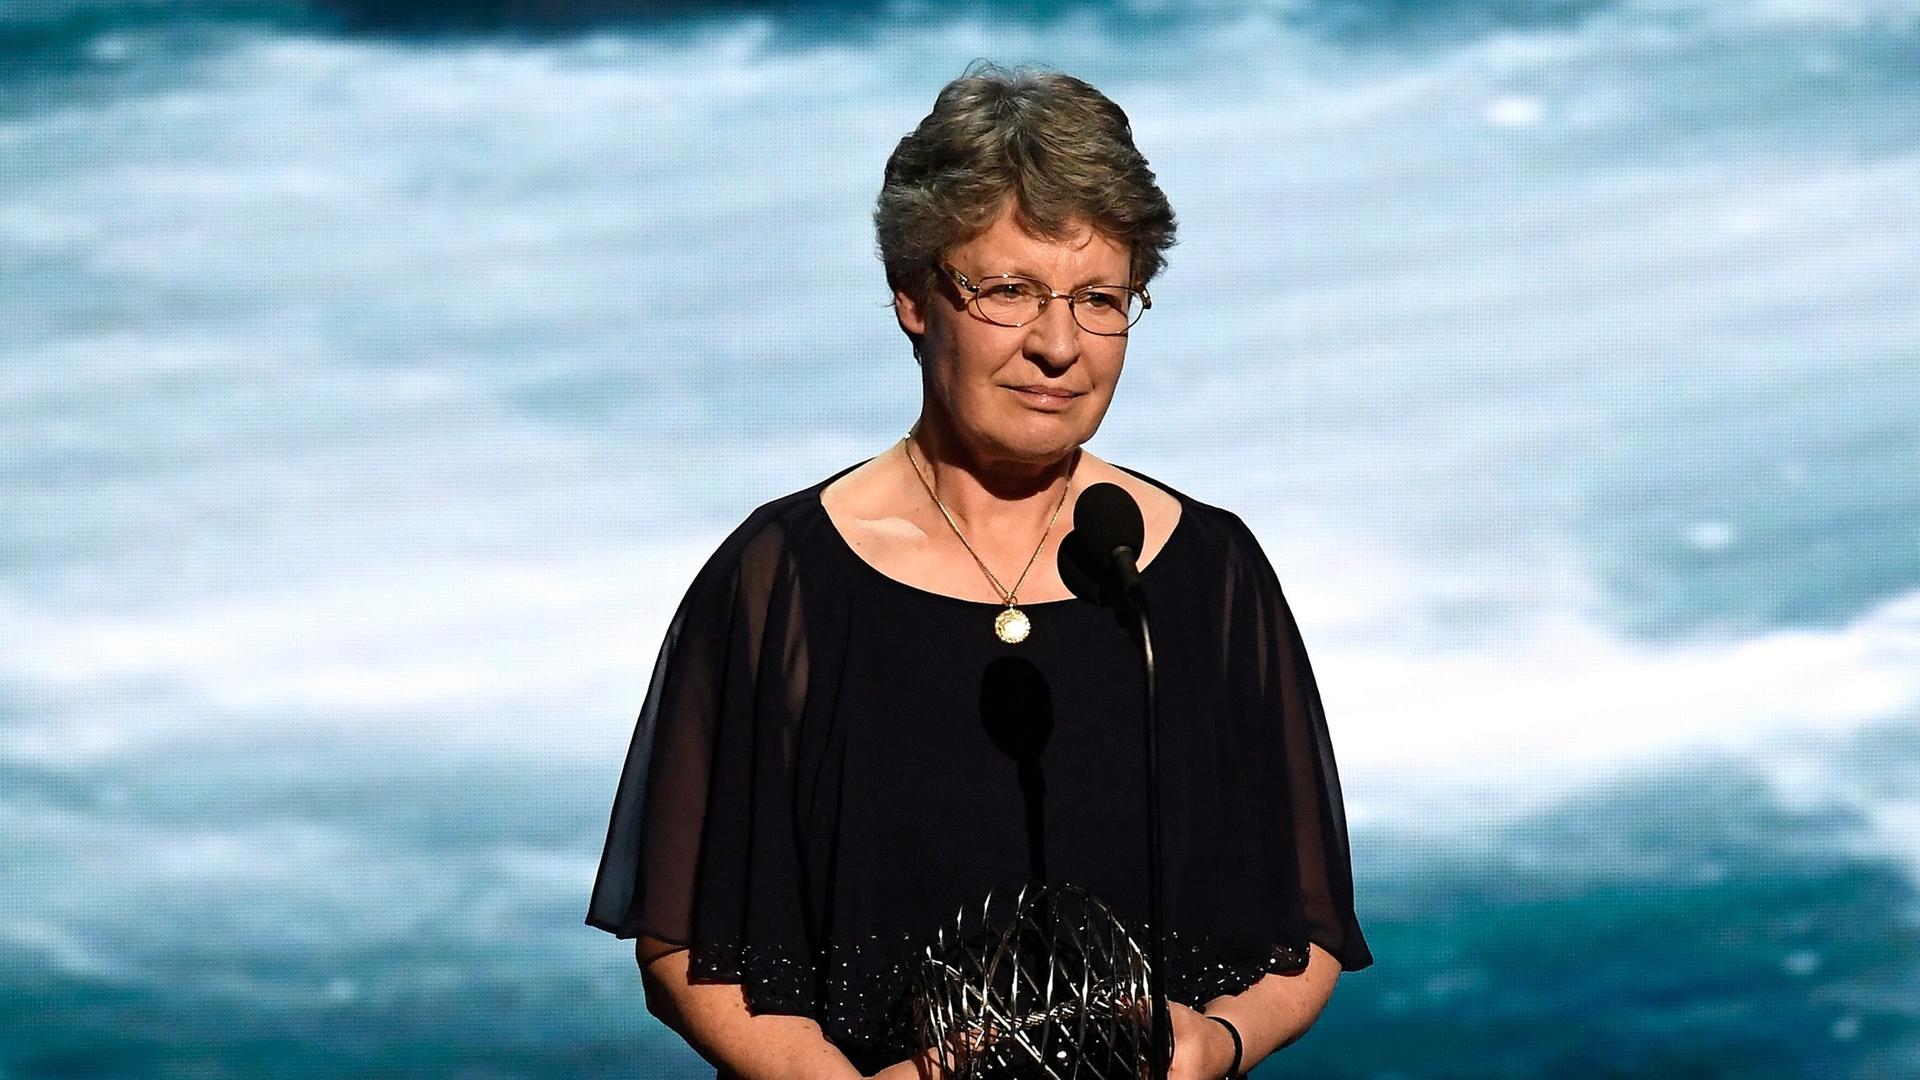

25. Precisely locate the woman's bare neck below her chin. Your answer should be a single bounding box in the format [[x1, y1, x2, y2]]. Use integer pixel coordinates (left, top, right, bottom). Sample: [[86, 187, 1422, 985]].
[[910, 413, 1079, 544]]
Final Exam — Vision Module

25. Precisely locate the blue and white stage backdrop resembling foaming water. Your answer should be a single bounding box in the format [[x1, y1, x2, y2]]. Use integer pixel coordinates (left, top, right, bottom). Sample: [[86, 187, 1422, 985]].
[[11, 0, 1920, 1080]]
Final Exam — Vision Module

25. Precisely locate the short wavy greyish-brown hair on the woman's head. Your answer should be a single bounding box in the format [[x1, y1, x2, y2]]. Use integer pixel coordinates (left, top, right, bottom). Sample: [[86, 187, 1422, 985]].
[[874, 63, 1173, 346]]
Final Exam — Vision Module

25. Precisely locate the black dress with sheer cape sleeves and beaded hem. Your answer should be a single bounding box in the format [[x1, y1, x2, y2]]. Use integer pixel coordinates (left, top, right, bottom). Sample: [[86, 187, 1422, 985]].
[[586, 461, 1373, 1070]]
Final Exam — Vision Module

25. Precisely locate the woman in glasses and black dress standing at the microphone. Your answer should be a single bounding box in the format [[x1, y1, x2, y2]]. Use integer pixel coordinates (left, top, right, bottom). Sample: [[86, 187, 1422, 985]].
[[588, 67, 1371, 1080]]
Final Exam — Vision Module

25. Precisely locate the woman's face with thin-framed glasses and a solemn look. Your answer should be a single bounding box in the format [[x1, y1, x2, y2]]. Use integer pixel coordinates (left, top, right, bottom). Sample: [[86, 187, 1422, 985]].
[[895, 205, 1131, 465]]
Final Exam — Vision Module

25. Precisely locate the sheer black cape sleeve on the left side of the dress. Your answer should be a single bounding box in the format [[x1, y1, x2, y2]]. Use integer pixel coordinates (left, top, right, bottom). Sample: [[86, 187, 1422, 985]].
[[586, 503, 816, 1015]]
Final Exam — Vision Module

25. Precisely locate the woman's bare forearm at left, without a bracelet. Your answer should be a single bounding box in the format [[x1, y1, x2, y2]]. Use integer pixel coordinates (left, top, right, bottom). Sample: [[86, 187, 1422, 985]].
[[634, 936, 860, 1080]]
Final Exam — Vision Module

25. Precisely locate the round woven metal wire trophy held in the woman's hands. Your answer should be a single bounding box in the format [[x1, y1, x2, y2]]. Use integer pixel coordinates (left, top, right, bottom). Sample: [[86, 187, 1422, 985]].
[[914, 884, 1152, 1080]]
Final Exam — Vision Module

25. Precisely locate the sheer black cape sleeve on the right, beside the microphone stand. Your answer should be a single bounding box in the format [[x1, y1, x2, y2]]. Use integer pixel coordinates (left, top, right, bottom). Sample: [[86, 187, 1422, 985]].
[[1221, 511, 1373, 970]]
